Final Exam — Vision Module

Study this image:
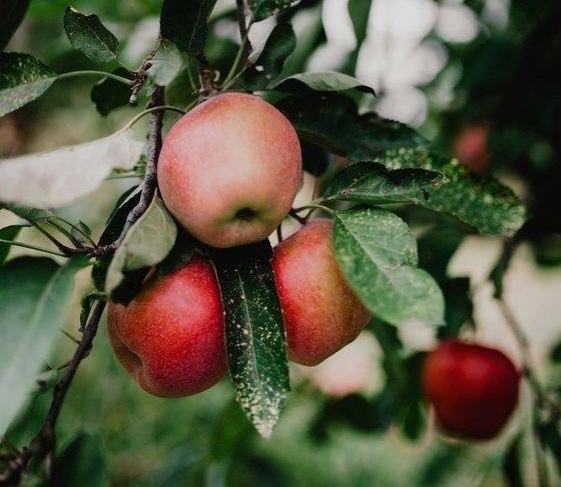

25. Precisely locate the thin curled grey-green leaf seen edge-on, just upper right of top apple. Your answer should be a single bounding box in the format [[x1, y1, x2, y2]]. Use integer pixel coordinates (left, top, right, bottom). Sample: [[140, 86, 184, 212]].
[[272, 71, 376, 95]]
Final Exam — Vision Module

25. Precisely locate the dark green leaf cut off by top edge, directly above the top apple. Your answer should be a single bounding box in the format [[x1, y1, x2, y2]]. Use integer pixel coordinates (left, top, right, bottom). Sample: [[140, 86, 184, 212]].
[[160, 0, 217, 55]]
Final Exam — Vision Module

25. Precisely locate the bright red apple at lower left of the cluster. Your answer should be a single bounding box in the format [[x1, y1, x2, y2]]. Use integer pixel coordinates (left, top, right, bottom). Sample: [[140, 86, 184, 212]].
[[107, 256, 227, 397]]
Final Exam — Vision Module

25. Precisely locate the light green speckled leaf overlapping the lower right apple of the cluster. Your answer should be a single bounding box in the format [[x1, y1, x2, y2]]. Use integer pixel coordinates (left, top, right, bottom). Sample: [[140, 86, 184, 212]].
[[333, 208, 444, 326]]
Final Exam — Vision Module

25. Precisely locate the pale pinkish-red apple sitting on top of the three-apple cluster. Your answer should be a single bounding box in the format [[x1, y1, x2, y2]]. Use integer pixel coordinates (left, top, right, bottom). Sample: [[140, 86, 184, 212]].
[[158, 93, 302, 248]]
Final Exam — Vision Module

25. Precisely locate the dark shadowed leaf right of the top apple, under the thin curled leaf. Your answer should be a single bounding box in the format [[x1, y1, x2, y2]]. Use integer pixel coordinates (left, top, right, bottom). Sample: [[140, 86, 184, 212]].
[[276, 91, 427, 157]]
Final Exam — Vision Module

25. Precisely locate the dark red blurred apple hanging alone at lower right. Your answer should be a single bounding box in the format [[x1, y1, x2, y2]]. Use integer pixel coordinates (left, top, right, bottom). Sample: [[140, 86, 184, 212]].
[[423, 339, 520, 440]]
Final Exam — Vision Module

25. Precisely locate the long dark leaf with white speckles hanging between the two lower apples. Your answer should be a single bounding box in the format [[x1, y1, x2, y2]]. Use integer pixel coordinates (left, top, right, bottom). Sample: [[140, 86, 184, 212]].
[[213, 241, 290, 437]]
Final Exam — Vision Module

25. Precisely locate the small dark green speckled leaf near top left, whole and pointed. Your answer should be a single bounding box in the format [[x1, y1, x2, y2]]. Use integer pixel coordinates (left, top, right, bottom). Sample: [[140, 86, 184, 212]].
[[64, 5, 119, 63]]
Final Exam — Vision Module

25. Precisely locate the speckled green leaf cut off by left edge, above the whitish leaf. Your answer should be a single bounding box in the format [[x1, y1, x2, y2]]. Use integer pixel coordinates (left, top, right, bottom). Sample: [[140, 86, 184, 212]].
[[0, 52, 57, 117]]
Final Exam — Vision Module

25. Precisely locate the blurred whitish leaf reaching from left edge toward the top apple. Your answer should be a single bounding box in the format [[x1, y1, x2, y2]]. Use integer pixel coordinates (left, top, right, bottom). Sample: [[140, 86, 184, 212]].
[[0, 130, 144, 208]]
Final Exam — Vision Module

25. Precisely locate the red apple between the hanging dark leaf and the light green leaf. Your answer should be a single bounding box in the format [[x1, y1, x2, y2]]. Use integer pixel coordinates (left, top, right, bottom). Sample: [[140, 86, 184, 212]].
[[272, 219, 370, 365]]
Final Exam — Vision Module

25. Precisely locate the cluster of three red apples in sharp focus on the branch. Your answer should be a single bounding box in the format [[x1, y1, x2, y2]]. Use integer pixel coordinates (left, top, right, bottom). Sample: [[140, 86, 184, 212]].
[[107, 93, 370, 397]]
